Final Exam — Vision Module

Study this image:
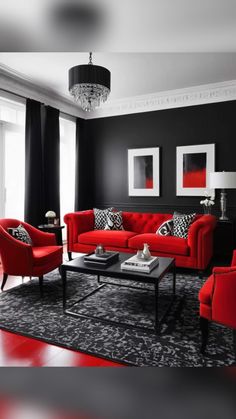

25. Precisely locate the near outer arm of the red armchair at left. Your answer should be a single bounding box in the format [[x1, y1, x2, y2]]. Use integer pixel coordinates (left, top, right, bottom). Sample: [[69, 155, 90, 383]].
[[0, 226, 33, 276]]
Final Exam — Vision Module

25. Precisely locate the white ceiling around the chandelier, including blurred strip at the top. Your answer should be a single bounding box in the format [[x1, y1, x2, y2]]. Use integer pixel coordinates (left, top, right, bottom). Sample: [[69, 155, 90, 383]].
[[0, 0, 236, 105]]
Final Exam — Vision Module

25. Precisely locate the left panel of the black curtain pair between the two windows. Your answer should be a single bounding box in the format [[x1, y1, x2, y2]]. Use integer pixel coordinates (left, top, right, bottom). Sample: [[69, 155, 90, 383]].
[[25, 99, 45, 226]]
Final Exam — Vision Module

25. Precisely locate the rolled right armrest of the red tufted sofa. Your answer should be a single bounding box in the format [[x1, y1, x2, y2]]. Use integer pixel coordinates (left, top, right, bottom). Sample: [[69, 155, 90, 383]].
[[188, 215, 217, 269]]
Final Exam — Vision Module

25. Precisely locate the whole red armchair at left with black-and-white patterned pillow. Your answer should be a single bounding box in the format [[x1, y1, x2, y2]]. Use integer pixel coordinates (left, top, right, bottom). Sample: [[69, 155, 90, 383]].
[[0, 218, 62, 295]]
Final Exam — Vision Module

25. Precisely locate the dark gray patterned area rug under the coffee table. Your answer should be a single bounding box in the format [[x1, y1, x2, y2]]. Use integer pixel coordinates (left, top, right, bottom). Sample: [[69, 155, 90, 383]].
[[0, 271, 235, 367]]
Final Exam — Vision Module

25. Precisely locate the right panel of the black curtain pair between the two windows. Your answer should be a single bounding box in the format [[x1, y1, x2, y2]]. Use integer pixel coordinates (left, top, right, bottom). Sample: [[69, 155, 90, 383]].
[[43, 106, 60, 221]]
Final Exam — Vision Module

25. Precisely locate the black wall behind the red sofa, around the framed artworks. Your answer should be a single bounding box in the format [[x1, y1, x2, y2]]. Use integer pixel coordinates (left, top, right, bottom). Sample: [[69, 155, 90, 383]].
[[79, 101, 236, 215]]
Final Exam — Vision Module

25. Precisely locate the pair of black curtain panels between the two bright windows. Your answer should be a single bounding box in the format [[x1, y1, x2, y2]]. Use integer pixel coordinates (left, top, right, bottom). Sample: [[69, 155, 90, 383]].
[[25, 99, 60, 227]]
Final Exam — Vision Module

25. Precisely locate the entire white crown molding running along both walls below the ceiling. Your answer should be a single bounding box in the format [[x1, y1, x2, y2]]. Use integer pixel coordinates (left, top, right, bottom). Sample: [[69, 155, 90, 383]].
[[0, 64, 236, 120]]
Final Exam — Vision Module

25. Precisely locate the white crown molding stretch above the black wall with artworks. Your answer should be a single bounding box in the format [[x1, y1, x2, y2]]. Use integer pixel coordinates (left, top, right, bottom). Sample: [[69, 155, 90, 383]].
[[86, 80, 236, 119]]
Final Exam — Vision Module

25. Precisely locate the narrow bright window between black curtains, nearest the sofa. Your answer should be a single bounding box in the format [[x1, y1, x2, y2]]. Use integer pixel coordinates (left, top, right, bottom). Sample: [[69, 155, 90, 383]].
[[60, 117, 76, 239]]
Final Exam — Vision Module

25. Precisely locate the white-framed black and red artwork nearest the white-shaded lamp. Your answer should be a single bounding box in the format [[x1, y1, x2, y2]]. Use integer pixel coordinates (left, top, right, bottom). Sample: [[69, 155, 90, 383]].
[[176, 144, 215, 196]]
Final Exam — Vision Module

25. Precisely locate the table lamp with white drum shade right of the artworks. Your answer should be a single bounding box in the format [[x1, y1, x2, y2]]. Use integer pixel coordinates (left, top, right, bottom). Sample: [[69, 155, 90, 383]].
[[209, 172, 236, 221]]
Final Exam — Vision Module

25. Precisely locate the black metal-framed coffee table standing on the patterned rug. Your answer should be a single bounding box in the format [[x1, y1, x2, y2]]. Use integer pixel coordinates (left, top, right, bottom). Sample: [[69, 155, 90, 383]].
[[61, 253, 176, 333]]
